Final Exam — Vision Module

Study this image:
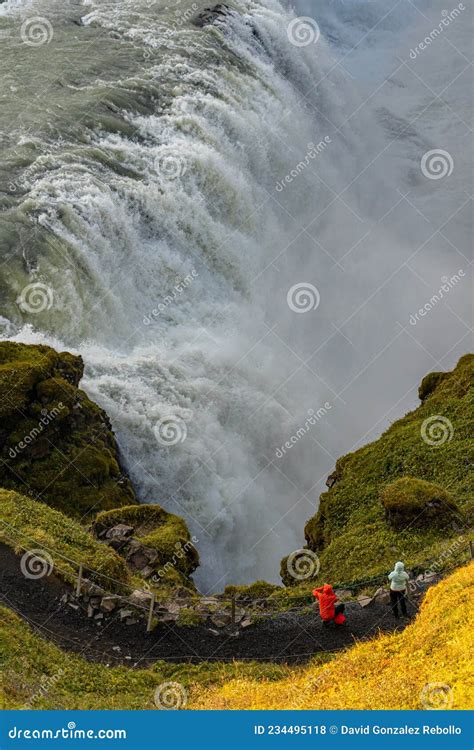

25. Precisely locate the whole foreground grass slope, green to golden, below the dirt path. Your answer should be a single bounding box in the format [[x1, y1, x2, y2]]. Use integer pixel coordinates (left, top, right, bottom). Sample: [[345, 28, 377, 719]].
[[0, 563, 474, 709]]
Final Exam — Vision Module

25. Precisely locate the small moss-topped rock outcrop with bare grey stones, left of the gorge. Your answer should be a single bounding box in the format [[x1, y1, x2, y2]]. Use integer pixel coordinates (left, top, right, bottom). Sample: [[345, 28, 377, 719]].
[[92, 505, 199, 588]]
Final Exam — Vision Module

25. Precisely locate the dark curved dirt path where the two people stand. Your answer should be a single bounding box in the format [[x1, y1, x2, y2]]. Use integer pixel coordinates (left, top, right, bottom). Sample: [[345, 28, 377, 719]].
[[0, 547, 422, 667]]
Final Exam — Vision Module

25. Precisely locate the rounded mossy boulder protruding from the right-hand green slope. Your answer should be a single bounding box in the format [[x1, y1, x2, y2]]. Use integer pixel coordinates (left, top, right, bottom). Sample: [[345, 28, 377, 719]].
[[380, 477, 458, 529]]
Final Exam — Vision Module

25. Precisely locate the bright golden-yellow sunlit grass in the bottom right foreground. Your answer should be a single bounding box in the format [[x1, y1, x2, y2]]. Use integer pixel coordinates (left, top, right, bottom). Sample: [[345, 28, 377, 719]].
[[188, 563, 474, 709]]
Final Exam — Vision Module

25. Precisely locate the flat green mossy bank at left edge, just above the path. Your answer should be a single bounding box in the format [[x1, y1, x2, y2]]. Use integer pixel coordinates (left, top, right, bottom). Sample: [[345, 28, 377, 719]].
[[0, 489, 131, 591]]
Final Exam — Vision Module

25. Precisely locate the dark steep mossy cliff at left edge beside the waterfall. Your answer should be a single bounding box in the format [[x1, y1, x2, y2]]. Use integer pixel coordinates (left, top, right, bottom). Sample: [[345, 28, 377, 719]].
[[0, 341, 136, 518]]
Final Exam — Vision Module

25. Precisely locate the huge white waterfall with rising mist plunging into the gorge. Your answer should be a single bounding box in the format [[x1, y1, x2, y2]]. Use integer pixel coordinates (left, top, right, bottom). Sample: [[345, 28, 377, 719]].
[[0, 0, 470, 589]]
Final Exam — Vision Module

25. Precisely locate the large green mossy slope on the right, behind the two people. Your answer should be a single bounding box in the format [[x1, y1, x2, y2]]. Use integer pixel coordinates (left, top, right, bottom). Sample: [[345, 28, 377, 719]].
[[282, 355, 474, 585]]
